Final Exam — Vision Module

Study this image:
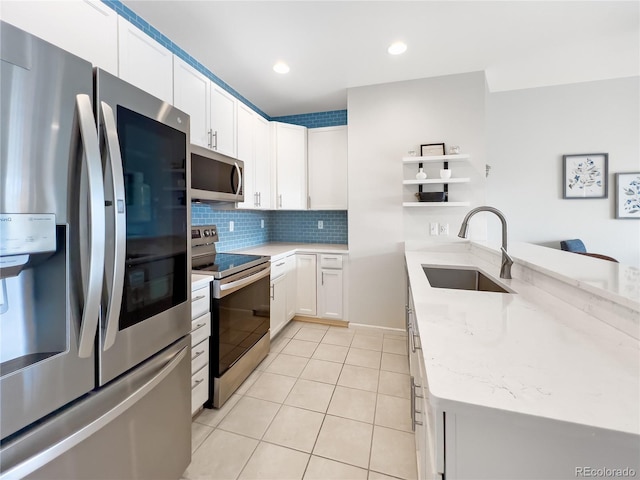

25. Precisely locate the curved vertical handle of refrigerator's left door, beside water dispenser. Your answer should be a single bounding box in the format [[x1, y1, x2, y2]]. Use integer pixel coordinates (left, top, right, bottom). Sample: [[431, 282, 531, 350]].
[[74, 94, 105, 358]]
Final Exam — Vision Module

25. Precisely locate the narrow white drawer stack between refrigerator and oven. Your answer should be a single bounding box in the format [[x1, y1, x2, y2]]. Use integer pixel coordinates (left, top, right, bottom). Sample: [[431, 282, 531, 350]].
[[191, 284, 211, 415]]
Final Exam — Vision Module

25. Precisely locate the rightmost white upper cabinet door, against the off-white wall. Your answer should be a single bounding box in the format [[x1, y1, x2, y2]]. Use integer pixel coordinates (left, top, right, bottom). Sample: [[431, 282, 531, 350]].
[[307, 125, 347, 210]]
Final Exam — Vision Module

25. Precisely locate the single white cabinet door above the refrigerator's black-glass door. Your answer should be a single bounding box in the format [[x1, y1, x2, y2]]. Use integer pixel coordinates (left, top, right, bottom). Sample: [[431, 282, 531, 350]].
[[118, 17, 173, 104]]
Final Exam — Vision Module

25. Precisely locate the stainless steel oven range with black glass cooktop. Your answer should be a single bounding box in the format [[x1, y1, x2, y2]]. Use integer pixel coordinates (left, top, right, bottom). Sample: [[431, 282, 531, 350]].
[[191, 225, 271, 408]]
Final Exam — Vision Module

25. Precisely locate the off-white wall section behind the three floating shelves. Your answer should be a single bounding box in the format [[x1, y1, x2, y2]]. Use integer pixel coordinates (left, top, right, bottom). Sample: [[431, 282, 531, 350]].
[[348, 72, 486, 328]]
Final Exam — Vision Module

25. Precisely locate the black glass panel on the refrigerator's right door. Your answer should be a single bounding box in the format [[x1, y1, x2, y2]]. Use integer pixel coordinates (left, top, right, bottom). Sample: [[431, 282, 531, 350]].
[[117, 106, 188, 330]]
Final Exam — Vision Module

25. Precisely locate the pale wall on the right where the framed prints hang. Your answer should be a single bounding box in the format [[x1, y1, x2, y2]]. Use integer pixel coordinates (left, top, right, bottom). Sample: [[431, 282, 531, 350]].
[[486, 77, 640, 266]]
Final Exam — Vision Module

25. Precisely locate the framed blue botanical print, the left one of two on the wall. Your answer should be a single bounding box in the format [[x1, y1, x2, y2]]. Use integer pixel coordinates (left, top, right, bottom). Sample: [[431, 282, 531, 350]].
[[562, 153, 609, 199]]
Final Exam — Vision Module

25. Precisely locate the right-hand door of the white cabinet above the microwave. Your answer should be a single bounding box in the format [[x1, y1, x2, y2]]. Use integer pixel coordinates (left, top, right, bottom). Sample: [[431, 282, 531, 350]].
[[211, 83, 238, 158]]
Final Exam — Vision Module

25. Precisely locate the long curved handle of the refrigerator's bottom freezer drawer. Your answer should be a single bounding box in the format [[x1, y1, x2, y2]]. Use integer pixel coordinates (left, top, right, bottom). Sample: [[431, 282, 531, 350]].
[[0, 346, 189, 480]]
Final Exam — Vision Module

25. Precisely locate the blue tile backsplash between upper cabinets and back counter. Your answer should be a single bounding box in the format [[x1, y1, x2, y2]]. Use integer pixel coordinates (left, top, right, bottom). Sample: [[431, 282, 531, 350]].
[[191, 203, 348, 252]]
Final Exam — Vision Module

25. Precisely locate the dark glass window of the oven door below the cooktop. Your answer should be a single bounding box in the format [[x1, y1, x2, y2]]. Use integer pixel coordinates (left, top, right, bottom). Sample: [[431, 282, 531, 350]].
[[211, 276, 270, 377]]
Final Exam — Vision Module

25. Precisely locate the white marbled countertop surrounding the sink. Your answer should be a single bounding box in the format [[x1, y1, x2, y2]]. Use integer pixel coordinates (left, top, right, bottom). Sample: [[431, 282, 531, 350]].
[[405, 244, 640, 434]]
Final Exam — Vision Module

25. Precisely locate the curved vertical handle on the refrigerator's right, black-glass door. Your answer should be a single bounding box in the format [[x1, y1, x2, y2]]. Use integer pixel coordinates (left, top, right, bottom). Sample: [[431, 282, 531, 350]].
[[100, 102, 127, 351]]
